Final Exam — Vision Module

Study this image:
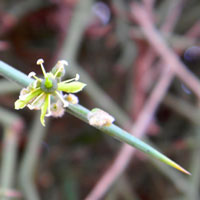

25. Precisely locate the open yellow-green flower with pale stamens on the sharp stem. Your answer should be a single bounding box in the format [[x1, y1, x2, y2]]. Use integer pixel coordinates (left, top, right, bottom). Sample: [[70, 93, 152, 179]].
[[15, 59, 86, 126]]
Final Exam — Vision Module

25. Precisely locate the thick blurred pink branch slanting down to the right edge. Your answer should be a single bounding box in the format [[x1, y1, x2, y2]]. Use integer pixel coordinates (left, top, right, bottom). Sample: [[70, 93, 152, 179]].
[[131, 3, 200, 98]]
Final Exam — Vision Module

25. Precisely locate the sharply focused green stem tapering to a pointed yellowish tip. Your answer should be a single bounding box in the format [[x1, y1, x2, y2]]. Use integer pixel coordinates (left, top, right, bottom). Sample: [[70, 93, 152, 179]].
[[0, 62, 190, 174]]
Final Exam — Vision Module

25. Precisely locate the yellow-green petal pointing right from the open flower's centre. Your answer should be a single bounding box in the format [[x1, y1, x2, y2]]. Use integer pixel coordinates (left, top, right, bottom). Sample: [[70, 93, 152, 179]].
[[58, 81, 86, 93]]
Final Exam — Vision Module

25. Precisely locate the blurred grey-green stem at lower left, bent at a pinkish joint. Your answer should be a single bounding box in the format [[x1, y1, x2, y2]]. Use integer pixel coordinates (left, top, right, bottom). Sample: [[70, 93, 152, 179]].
[[0, 108, 23, 200]]
